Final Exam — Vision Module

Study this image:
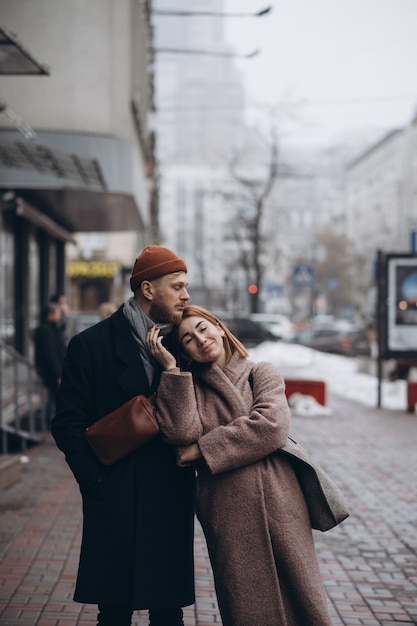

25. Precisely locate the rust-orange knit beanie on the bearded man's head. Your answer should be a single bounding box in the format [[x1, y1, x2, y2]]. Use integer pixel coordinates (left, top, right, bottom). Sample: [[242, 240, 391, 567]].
[[130, 246, 188, 292]]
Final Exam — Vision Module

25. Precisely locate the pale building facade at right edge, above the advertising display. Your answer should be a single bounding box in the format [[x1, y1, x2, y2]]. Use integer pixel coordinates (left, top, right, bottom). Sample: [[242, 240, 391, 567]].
[[344, 113, 417, 310]]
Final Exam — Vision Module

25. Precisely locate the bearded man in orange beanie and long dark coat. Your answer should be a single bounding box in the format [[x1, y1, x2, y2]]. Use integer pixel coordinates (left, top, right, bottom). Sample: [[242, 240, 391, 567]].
[[52, 246, 194, 626]]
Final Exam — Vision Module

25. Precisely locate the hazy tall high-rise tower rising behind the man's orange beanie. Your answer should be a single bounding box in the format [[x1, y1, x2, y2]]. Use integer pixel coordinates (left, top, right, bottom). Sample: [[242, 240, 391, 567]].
[[153, 0, 250, 302]]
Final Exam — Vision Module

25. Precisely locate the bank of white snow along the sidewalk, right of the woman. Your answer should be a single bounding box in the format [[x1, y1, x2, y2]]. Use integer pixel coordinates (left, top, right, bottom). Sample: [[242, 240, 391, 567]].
[[249, 342, 407, 410]]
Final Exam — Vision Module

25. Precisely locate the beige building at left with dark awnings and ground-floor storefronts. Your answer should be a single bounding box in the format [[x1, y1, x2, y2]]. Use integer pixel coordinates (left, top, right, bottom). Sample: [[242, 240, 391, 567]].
[[0, 0, 158, 448]]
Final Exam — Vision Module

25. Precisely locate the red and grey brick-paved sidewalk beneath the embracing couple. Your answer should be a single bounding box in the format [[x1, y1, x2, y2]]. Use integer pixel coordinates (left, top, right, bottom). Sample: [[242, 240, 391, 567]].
[[0, 398, 417, 626]]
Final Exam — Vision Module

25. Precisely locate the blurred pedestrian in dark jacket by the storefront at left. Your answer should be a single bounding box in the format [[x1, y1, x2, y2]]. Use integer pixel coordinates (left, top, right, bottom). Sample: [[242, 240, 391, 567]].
[[34, 302, 66, 426]]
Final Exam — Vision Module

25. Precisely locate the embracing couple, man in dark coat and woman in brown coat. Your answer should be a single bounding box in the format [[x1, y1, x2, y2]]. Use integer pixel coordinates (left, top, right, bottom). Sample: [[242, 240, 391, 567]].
[[52, 246, 331, 626]]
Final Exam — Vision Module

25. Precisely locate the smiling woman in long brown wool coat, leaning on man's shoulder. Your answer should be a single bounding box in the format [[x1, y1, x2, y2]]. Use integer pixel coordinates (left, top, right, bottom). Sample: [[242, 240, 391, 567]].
[[147, 306, 331, 626]]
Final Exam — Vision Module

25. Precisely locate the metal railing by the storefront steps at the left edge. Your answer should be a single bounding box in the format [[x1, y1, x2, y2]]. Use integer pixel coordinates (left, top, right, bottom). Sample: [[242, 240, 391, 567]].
[[0, 340, 46, 453]]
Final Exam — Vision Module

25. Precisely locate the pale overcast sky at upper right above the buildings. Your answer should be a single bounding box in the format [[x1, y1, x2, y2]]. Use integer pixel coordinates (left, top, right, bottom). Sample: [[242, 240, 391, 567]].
[[225, 0, 417, 145]]
